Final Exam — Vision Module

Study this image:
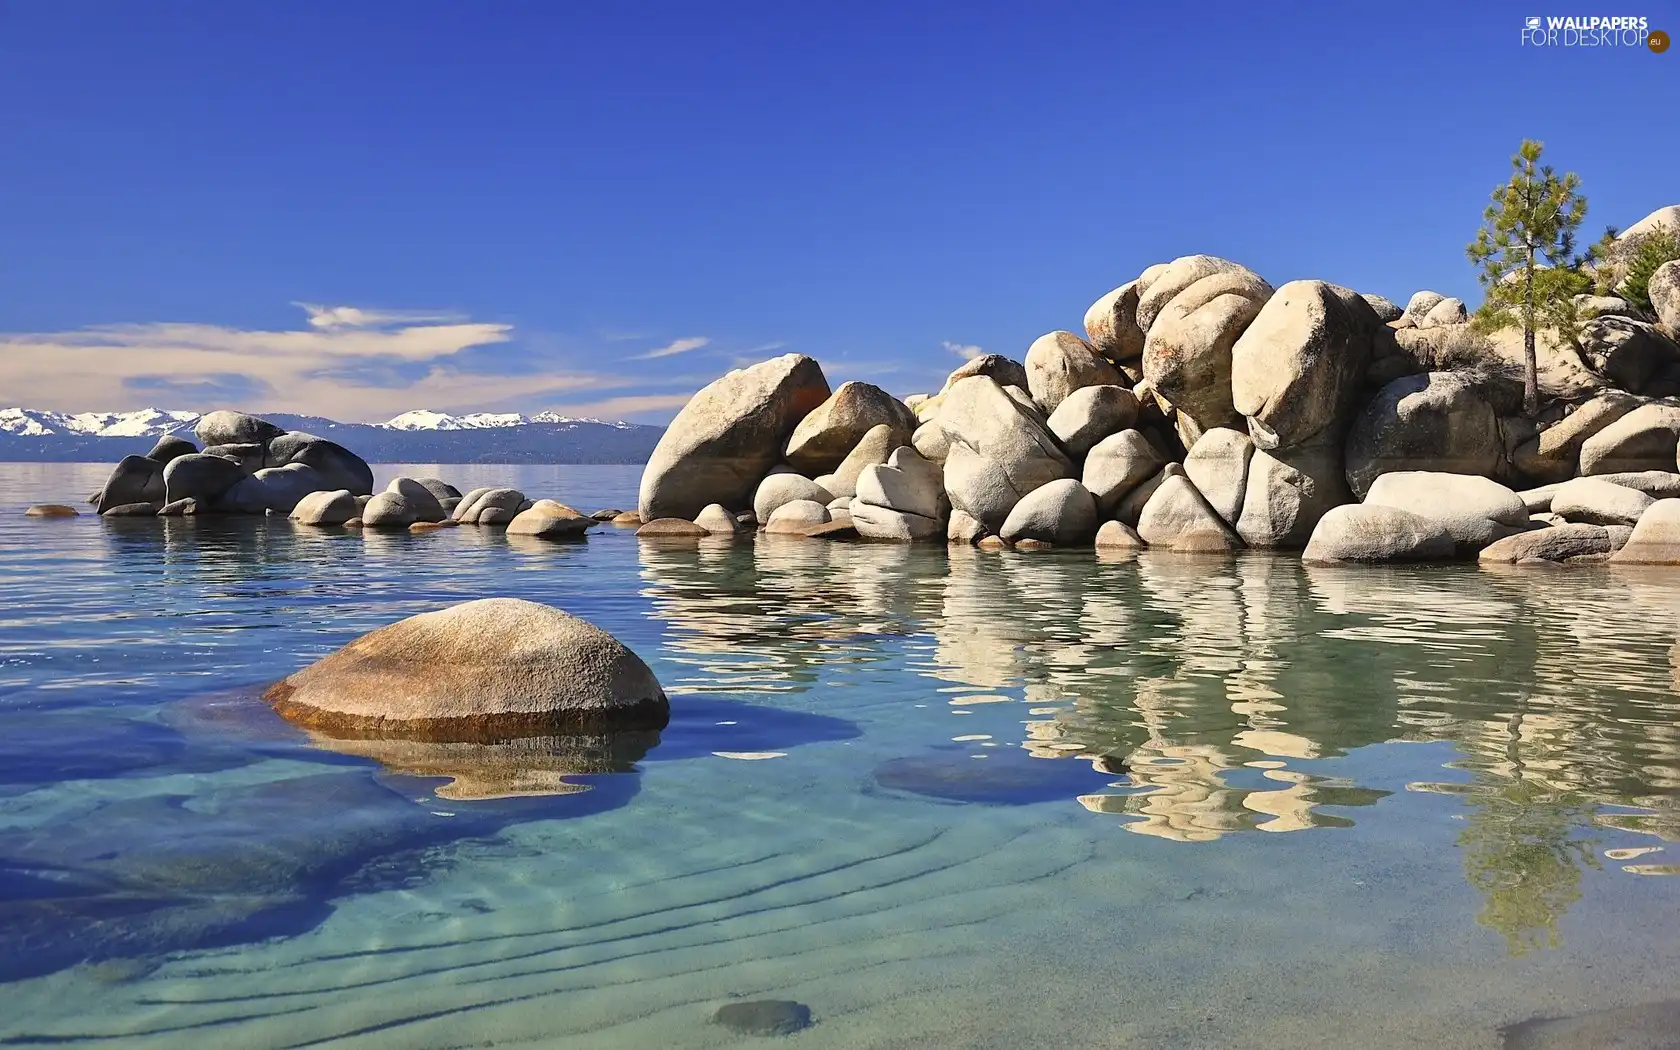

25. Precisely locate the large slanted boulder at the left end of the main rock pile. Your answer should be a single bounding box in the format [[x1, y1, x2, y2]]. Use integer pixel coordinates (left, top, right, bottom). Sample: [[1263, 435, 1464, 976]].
[[638, 354, 829, 521]]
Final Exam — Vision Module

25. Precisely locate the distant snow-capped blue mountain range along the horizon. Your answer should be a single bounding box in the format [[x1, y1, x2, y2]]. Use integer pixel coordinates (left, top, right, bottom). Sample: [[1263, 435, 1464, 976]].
[[0, 408, 665, 464]]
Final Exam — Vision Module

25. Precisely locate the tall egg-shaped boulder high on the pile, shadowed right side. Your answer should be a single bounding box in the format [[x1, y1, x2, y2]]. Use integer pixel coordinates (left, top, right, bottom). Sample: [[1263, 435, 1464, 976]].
[[1231, 281, 1378, 449]]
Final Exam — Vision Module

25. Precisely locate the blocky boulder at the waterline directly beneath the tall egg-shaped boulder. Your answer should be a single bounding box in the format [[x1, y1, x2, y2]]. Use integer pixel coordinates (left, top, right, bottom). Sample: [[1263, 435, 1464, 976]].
[[1236, 435, 1352, 549]]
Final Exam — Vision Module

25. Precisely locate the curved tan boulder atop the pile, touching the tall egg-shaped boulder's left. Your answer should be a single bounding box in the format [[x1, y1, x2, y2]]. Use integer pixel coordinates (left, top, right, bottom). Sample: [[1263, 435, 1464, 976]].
[[1142, 267, 1272, 430]]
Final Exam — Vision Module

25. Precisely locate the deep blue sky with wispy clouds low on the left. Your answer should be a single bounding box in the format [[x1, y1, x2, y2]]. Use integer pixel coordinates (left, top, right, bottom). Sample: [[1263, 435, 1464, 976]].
[[0, 0, 1680, 422]]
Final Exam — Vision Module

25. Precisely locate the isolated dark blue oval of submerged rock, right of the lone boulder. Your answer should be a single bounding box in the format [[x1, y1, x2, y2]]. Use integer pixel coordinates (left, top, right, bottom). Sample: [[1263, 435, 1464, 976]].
[[875, 748, 1121, 806]]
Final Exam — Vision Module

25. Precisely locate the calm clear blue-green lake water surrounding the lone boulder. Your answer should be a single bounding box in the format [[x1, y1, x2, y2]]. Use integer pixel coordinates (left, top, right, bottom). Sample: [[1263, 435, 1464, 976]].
[[0, 464, 1680, 1050]]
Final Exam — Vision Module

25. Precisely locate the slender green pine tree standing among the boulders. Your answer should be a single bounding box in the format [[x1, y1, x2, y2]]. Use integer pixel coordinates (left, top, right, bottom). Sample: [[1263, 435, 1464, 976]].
[[1465, 139, 1591, 415]]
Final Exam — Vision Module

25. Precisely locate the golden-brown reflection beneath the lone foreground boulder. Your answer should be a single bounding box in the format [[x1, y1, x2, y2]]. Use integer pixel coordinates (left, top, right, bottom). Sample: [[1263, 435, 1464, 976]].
[[311, 729, 659, 801]]
